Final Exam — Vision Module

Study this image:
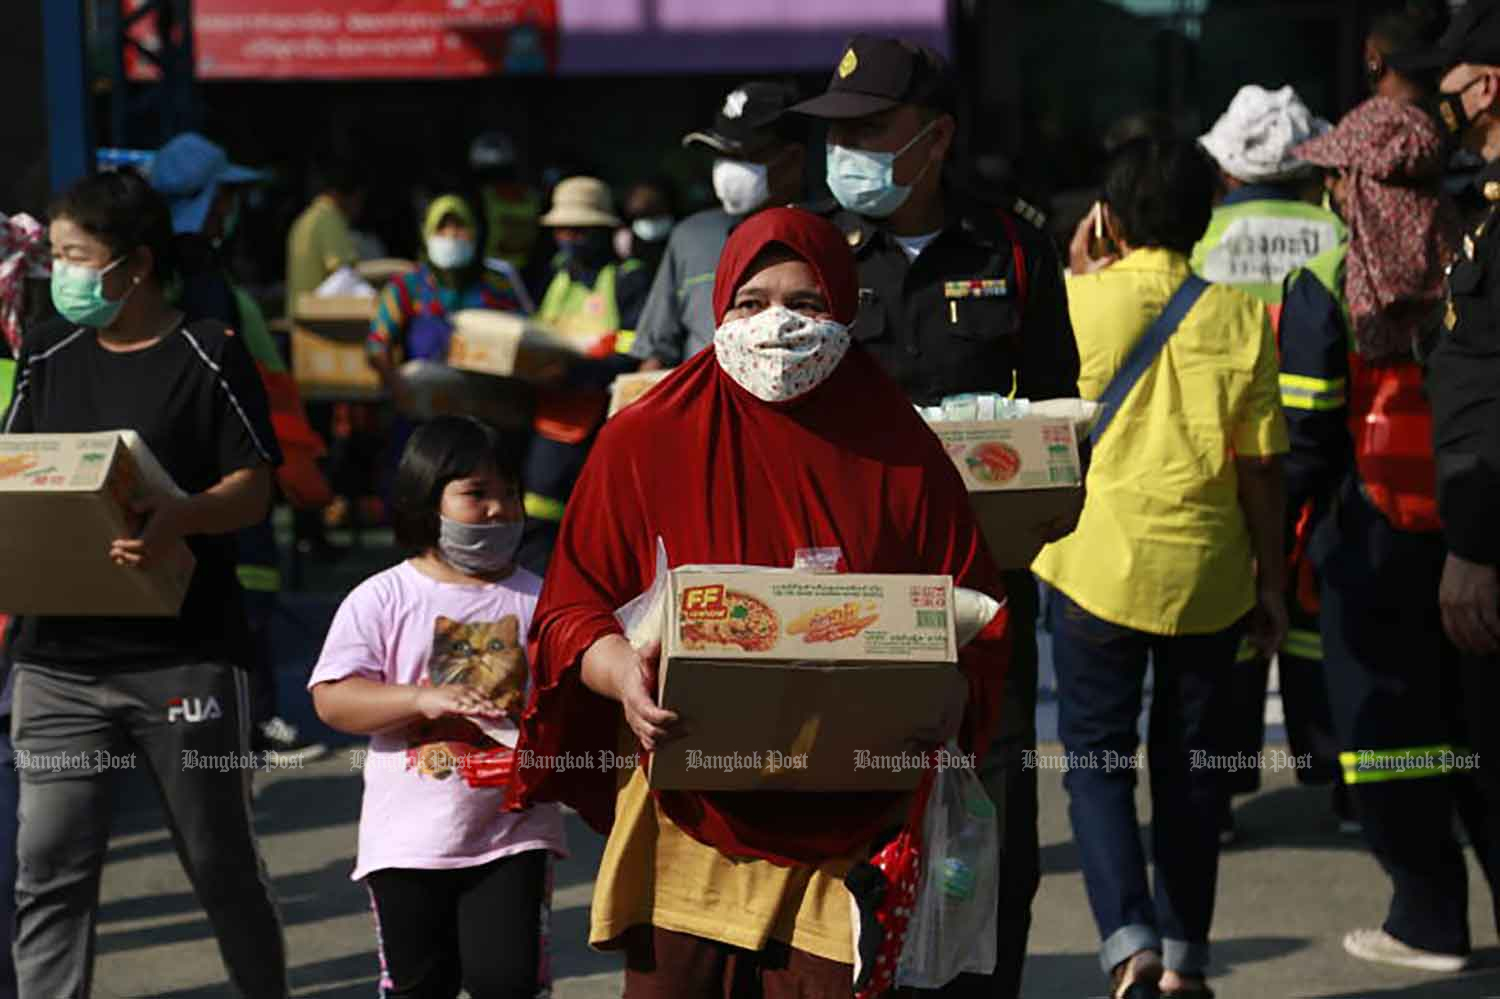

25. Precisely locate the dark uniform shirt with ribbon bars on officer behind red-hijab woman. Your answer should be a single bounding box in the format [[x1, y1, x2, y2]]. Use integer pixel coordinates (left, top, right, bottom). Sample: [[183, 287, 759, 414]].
[[813, 195, 1079, 405]]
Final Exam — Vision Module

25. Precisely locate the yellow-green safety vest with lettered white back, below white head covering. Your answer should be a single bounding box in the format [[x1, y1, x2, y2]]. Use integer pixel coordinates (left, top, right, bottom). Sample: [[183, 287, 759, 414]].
[[1193, 201, 1349, 306]]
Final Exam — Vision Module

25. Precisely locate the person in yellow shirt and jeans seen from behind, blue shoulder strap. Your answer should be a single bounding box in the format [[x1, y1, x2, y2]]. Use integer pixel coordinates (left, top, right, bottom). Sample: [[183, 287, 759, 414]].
[[1032, 138, 1287, 999]]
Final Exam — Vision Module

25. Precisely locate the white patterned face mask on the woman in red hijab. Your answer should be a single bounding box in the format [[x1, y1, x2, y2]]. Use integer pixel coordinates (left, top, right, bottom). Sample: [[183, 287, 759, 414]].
[[714, 306, 849, 402]]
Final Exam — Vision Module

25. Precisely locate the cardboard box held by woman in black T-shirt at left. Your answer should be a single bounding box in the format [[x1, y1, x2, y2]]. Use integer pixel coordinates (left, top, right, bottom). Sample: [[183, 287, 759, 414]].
[[0, 431, 194, 617]]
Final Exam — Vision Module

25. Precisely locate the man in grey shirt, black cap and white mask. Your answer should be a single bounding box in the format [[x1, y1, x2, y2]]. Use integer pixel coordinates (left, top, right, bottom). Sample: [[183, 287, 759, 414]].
[[621, 80, 807, 371]]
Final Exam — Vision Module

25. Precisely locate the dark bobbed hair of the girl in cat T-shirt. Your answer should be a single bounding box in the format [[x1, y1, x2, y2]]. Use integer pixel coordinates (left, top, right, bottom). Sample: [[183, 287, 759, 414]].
[[392, 417, 521, 552]]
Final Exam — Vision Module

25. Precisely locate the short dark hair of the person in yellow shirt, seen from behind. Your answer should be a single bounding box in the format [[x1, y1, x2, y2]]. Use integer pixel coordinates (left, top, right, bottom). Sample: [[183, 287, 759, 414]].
[[1104, 137, 1218, 254]]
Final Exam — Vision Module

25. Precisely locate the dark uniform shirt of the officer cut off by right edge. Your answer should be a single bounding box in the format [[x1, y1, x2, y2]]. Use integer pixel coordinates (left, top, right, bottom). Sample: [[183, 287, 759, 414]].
[[1427, 164, 1500, 566]]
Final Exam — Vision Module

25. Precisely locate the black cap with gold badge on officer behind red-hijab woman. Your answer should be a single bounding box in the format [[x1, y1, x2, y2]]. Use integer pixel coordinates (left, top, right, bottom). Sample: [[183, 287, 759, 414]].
[[792, 35, 959, 119]]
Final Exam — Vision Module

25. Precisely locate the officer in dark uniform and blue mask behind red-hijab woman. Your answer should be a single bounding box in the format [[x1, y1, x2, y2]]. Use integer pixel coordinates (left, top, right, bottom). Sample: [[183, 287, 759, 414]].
[[794, 36, 1079, 998]]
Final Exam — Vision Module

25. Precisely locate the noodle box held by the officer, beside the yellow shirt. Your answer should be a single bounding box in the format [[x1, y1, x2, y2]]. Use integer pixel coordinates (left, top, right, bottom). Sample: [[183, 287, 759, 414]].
[[930, 416, 1083, 569]]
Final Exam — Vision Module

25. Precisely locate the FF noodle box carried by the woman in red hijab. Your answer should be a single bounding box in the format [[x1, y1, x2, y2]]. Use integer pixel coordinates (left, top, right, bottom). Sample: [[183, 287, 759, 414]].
[[650, 569, 966, 791]]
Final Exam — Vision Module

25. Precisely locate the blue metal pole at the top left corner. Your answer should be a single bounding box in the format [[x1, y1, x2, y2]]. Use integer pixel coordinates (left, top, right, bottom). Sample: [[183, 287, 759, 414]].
[[36, 0, 93, 191]]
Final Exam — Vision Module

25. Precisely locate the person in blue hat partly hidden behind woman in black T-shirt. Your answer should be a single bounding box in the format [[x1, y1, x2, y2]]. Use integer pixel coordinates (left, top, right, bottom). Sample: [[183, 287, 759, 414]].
[[150, 132, 332, 764]]
